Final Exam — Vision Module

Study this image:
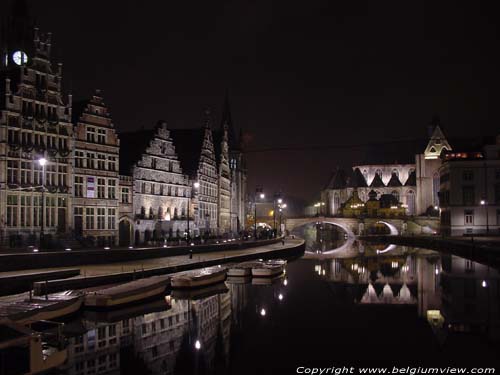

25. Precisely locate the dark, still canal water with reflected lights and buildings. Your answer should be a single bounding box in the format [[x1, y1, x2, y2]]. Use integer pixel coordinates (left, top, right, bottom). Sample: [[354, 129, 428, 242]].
[[58, 229, 500, 374]]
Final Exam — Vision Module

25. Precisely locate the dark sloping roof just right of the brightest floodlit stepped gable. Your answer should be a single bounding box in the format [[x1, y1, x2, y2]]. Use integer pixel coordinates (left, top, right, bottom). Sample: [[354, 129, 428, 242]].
[[170, 128, 205, 177]]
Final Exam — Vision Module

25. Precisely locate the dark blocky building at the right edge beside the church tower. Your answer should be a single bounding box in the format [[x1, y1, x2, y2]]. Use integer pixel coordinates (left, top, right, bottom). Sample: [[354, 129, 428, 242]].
[[439, 136, 500, 236]]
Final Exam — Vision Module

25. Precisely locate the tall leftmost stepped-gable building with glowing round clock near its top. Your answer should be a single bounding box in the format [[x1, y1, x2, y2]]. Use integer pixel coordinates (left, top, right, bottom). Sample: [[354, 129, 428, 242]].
[[0, 21, 74, 250]]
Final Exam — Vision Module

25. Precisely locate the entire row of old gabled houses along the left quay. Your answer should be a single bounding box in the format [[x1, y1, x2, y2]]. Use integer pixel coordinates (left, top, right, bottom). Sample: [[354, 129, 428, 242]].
[[0, 7, 246, 246]]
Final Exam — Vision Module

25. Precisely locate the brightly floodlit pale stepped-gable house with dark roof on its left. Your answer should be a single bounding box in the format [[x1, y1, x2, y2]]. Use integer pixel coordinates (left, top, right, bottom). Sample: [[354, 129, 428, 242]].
[[120, 121, 192, 245]]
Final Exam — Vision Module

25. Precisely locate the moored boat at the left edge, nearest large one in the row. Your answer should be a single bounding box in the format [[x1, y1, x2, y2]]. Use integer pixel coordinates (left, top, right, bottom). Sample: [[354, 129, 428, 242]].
[[0, 291, 84, 325]]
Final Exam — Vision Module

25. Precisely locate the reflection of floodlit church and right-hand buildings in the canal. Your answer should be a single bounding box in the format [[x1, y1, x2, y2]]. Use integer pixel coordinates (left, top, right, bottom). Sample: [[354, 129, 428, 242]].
[[314, 244, 500, 340]]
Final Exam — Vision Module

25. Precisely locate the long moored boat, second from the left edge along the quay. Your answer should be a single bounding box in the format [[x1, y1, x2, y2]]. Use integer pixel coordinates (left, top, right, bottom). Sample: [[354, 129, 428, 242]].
[[85, 276, 170, 307]]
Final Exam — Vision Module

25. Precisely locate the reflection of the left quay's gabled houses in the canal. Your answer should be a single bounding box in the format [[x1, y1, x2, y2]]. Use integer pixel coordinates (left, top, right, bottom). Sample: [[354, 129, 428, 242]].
[[63, 288, 234, 375]]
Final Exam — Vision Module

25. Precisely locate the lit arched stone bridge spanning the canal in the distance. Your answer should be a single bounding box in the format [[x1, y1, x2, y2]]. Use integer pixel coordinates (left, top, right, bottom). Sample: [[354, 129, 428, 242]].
[[285, 216, 407, 238]]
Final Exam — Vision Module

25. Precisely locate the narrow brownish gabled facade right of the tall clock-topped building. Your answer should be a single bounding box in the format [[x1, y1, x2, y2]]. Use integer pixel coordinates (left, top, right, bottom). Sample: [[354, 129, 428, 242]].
[[73, 90, 120, 245]]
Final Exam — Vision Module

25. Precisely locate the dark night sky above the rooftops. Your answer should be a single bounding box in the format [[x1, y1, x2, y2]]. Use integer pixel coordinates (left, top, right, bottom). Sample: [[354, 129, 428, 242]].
[[26, 0, 500, 203]]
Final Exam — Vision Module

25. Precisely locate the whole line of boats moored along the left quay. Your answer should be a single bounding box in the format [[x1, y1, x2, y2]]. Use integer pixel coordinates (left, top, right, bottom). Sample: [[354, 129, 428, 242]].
[[0, 260, 286, 374]]
